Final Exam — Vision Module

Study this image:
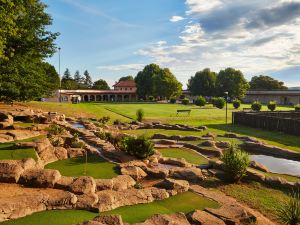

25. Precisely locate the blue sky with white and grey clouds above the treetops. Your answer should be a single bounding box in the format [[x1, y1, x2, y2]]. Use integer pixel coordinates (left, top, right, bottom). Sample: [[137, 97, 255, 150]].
[[42, 0, 300, 87]]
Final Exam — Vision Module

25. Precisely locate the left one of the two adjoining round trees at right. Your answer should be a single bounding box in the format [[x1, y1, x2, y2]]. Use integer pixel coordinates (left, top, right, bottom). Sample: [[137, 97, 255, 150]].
[[187, 68, 217, 96]]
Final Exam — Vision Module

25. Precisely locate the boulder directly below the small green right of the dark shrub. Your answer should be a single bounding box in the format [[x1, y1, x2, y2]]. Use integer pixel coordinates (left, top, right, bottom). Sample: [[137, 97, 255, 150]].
[[170, 167, 204, 183]]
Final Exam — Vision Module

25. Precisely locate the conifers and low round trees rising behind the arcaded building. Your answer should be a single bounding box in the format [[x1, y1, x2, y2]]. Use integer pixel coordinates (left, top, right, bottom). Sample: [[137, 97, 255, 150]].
[[61, 69, 110, 90]]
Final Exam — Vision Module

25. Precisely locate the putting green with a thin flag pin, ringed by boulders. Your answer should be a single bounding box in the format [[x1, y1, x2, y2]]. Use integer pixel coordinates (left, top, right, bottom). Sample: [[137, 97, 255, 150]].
[[46, 155, 118, 179]]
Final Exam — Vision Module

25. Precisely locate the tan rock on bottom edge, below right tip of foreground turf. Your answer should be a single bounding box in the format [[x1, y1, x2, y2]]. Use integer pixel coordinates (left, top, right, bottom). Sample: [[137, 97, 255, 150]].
[[190, 210, 226, 225]]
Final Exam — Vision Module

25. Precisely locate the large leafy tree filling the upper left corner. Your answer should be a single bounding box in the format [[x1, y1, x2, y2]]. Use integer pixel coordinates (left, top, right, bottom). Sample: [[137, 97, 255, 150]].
[[0, 0, 58, 101]]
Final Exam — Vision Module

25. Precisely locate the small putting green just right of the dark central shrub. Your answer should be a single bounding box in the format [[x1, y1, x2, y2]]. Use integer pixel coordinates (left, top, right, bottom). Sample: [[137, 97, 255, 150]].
[[157, 148, 208, 165]]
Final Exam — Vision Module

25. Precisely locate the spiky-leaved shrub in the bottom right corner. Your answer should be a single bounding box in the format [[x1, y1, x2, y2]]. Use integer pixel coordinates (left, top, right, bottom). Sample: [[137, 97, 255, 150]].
[[276, 190, 300, 225]]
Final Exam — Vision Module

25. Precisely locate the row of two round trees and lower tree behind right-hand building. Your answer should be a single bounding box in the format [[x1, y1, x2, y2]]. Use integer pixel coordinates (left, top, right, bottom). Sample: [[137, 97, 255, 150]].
[[187, 68, 287, 99]]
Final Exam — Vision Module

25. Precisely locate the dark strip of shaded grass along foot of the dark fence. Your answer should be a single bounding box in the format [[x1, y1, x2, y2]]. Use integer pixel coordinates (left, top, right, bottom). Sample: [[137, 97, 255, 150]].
[[206, 124, 300, 148]]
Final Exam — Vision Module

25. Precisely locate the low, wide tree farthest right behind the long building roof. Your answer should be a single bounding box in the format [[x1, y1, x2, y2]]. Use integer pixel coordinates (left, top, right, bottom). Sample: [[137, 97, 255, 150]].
[[250, 75, 288, 90]]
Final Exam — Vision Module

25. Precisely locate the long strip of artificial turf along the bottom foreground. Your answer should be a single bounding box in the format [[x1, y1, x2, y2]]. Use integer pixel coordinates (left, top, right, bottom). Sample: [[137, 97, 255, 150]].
[[1, 192, 219, 225]]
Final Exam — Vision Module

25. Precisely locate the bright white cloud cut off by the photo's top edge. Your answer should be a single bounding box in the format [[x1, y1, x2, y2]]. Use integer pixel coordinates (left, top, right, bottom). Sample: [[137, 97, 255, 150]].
[[185, 0, 223, 15]]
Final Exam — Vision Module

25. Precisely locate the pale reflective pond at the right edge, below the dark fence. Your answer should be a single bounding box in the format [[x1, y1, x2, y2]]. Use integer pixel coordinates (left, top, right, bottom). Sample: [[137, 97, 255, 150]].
[[250, 155, 300, 177]]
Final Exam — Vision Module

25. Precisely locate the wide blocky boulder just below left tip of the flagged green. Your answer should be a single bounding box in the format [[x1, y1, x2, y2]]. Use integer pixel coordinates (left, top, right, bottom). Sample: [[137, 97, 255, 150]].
[[19, 169, 61, 187]]
